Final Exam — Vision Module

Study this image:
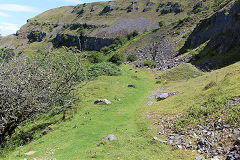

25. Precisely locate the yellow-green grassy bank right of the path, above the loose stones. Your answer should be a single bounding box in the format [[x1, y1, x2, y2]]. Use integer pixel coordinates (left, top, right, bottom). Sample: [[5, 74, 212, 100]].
[[147, 62, 240, 130]]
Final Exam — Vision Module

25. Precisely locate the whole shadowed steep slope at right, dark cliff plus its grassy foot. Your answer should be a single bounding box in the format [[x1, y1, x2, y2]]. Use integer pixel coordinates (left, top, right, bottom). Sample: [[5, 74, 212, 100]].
[[181, 1, 240, 71]]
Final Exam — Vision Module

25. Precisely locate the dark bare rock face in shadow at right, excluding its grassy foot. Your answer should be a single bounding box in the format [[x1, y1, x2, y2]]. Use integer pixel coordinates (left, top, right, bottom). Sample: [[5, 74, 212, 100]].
[[185, 3, 240, 53]]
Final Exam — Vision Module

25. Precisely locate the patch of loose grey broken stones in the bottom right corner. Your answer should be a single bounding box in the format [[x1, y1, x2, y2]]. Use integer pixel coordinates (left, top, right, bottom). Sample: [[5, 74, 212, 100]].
[[155, 113, 240, 160]]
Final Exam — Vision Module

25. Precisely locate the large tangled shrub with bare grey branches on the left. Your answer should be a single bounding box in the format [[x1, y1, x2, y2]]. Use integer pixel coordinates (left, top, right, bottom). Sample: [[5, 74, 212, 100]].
[[0, 52, 83, 145]]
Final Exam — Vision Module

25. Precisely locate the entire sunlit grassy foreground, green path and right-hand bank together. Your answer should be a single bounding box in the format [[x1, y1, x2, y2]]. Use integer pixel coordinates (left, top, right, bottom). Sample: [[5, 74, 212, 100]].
[[3, 60, 240, 159]]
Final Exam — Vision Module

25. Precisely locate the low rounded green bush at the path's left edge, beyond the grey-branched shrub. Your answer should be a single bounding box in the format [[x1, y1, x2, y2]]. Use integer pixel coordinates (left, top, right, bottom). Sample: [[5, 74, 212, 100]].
[[87, 62, 121, 79]]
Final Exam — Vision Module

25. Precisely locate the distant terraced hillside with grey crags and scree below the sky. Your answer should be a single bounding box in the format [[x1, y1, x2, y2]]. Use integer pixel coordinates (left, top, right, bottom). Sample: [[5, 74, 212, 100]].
[[0, 0, 217, 50]]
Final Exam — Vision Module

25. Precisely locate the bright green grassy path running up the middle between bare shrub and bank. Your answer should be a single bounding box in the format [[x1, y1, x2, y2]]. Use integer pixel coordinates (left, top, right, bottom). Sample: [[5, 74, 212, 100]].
[[5, 67, 191, 160]]
